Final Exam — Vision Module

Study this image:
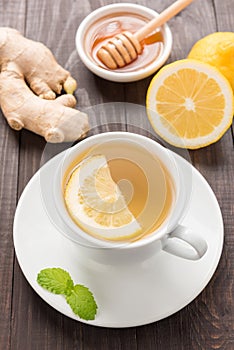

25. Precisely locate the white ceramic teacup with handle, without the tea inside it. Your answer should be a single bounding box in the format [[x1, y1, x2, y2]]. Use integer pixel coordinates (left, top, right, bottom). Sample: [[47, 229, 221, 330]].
[[53, 132, 207, 264]]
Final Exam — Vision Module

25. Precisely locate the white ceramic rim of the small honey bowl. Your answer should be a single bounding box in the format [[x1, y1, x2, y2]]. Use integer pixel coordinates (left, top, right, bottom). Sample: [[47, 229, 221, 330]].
[[75, 3, 172, 82]]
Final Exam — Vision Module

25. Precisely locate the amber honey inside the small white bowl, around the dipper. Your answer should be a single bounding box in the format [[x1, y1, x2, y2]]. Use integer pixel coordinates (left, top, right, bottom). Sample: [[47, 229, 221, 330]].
[[85, 12, 164, 73]]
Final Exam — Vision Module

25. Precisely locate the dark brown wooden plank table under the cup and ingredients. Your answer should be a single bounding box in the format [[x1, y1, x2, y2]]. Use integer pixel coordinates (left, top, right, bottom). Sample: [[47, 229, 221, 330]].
[[0, 0, 234, 350]]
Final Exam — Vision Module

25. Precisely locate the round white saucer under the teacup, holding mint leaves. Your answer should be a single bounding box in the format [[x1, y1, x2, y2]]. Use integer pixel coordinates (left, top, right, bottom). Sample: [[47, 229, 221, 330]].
[[14, 151, 223, 327]]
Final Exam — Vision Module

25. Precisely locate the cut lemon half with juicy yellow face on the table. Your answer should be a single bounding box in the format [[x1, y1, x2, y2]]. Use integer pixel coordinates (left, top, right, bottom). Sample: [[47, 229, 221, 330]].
[[146, 59, 234, 149]]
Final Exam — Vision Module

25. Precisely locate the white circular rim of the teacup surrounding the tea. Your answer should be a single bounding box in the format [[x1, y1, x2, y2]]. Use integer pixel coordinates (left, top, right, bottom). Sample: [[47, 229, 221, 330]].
[[53, 131, 185, 248]]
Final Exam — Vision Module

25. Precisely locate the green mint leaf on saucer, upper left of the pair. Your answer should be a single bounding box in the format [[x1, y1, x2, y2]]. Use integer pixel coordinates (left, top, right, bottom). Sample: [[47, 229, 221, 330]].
[[37, 267, 74, 295]]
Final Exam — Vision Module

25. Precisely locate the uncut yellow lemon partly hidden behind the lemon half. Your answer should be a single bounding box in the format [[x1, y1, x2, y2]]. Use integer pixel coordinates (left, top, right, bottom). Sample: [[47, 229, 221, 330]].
[[188, 32, 234, 91]]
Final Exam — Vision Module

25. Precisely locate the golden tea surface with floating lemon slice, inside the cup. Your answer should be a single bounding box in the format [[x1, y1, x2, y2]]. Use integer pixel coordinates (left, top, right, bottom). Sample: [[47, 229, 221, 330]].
[[63, 139, 174, 241]]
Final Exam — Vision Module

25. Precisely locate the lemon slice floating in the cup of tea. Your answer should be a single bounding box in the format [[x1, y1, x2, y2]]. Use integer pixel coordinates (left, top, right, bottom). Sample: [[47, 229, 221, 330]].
[[64, 155, 142, 241]]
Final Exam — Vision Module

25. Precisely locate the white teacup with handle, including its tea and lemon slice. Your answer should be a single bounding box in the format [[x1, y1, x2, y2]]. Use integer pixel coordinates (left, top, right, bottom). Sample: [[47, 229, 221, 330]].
[[54, 132, 207, 259]]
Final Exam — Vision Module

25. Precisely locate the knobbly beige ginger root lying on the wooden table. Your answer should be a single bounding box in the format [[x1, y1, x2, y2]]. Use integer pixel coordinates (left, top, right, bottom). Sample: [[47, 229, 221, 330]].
[[0, 28, 88, 142]]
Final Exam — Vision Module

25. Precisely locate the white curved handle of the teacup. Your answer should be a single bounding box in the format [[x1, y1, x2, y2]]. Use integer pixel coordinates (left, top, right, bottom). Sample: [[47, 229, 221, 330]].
[[162, 225, 208, 260]]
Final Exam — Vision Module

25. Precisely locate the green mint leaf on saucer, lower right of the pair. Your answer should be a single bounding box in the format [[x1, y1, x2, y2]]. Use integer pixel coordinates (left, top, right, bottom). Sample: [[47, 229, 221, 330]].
[[66, 284, 97, 320]]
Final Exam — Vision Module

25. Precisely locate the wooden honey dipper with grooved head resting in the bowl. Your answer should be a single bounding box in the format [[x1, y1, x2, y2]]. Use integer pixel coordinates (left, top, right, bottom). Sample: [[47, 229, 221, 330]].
[[97, 0, 193, 69]]
